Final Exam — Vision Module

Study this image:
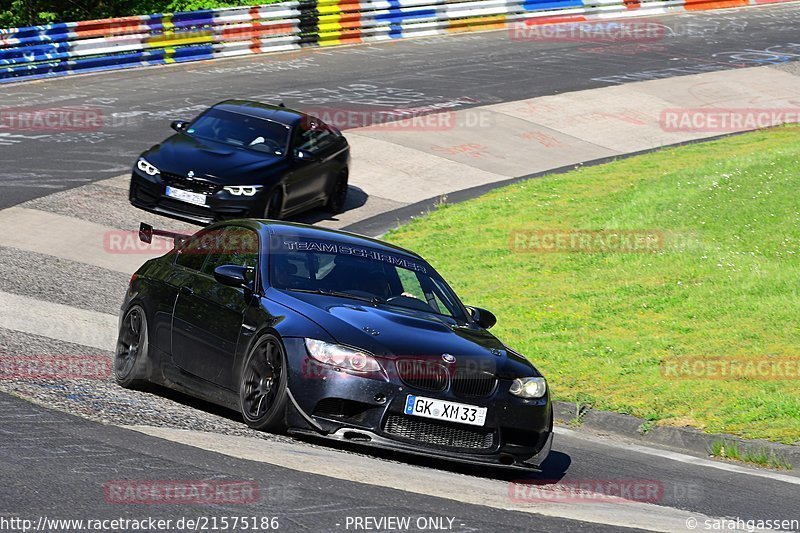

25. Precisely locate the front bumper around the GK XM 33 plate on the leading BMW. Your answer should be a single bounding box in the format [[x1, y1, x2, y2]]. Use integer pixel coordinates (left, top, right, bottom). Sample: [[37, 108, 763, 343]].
[[284, 339, 553, 469]]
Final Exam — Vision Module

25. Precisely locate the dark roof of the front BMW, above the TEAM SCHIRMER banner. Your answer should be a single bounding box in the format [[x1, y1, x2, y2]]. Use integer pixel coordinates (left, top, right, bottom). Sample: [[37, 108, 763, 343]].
[[208, 218, 427, 263]]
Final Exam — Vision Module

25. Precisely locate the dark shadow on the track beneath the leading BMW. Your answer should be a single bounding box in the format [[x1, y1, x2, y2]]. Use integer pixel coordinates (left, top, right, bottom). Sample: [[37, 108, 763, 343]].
[[136, 385, 572, 484]]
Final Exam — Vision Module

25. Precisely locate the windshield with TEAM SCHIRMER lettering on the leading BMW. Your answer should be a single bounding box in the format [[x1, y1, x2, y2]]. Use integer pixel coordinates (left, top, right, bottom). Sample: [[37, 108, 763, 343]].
[[270, 238, 466, 322]]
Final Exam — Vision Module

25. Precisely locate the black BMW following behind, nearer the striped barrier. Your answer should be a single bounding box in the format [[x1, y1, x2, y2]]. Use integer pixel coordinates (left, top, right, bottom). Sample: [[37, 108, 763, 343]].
[[130, 100, 350, 224]]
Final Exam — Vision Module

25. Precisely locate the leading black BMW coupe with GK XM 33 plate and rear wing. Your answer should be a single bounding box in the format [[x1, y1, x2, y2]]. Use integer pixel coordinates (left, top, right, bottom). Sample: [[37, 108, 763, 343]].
[[114, 219, 553, 469]]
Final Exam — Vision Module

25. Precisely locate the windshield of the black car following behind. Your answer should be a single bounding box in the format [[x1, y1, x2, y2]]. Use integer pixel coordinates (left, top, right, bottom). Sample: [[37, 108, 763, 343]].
[[186, 109, 289, 155]]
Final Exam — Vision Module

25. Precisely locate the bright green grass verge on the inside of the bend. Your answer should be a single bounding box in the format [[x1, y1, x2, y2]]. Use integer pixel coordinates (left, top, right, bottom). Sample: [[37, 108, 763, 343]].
[[387, 126, 800, 443]]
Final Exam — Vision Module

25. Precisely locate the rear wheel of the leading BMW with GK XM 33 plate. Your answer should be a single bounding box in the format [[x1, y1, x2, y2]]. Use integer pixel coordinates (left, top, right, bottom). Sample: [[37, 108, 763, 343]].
[[114, 305, 149, 389]]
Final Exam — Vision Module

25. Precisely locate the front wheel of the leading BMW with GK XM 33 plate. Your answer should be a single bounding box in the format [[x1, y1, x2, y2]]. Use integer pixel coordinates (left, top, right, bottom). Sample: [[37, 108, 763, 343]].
[[239, 334, 289, 433]]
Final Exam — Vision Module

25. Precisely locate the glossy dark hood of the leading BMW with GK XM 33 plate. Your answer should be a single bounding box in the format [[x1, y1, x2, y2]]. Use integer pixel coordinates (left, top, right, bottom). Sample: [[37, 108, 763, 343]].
[[270, 289, 538, 377]]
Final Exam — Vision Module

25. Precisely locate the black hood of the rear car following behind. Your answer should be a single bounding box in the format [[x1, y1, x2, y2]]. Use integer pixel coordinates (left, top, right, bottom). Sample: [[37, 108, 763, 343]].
[[142, 133, 286, 185]]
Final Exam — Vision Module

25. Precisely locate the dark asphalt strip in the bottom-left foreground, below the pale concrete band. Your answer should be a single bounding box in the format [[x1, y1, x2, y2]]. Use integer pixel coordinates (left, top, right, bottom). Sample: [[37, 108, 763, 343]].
[[0, 394, 636, 532]]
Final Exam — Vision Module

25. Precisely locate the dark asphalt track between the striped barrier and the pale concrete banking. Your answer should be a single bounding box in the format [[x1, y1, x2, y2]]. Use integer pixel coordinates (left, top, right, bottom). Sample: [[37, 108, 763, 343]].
[[0, 4, 800, 208]]
